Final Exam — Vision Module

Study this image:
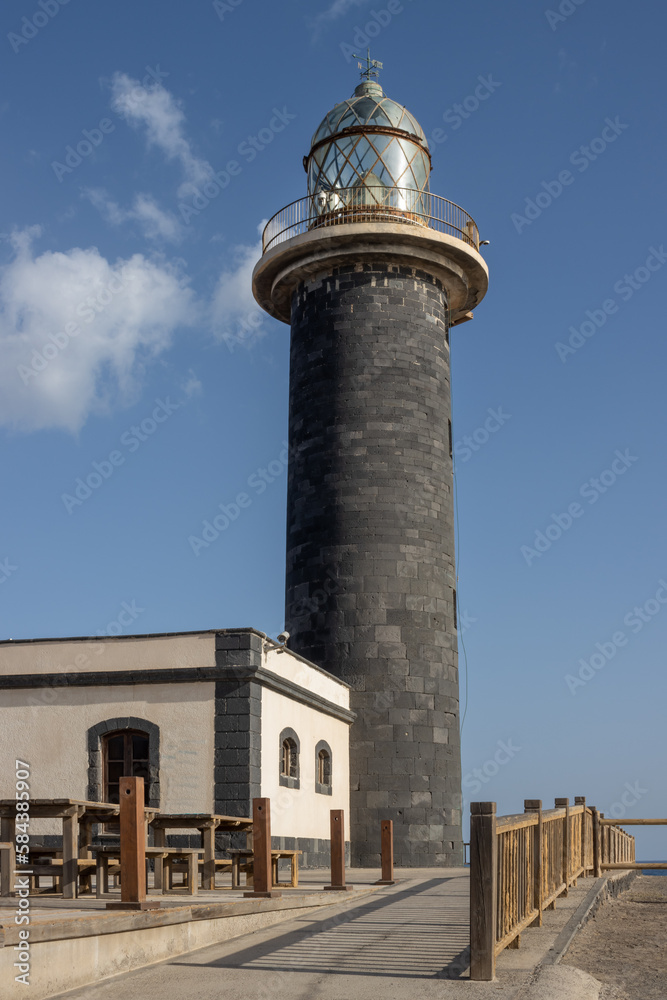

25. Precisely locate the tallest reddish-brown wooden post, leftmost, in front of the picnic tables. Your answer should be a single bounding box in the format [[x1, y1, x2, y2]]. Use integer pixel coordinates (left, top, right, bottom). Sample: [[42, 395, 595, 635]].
[[107, 778, 162, 910]]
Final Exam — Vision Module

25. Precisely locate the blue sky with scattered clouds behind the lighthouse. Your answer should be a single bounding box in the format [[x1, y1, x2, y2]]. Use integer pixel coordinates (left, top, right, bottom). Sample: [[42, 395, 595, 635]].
[[0, 0, 667, 856]]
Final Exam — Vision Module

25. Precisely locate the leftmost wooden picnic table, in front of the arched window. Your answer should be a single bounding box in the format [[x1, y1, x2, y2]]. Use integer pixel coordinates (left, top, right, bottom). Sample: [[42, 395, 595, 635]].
[[0, 799, 157, 899]]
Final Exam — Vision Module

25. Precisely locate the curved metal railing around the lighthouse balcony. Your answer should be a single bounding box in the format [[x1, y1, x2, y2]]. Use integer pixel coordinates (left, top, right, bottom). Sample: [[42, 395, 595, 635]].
[[262, 186, 479, 253]]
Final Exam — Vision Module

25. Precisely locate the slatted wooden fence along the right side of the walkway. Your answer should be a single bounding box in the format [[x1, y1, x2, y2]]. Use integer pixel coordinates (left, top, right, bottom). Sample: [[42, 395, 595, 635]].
[[470, 797, 640, 980]]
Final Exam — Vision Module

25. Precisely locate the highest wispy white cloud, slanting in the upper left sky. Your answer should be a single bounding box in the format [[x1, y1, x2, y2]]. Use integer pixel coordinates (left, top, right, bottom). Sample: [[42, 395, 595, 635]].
[[111, 73, 214, 198]]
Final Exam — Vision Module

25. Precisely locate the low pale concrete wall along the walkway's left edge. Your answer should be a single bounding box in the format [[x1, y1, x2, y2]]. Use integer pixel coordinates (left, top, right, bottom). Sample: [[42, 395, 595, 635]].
[[0, 888, 375, 1000]]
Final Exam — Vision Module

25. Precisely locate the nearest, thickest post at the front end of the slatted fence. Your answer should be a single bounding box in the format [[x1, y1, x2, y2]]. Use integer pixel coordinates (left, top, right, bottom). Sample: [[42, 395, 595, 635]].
[[470, 802, 498, 981]]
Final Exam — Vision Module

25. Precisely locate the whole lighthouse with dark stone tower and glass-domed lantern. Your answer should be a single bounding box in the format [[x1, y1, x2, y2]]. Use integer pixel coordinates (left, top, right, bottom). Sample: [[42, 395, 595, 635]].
[[253, 57, 488, 866]]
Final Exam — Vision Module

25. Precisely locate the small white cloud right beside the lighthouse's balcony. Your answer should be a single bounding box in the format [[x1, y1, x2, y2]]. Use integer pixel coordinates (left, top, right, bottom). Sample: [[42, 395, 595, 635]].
[[210, 230, 266, 350]]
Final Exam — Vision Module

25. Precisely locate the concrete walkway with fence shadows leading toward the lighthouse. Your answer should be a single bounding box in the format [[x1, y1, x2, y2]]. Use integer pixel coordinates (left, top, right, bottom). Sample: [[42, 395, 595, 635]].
[[51, 869, 620, 1000]]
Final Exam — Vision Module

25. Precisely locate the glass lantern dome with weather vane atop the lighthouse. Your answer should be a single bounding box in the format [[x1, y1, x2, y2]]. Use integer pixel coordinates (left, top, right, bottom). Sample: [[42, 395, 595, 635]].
[[304, 53, 431, 222]]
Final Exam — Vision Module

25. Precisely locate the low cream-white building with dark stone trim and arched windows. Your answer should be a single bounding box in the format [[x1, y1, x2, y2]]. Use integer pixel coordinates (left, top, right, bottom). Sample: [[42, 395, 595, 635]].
[[0, 629, 354, 866]]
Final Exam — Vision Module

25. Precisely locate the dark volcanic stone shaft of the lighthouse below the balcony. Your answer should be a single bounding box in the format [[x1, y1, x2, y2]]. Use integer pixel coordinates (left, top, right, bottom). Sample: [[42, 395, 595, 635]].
[[286, 262, 462, 866]]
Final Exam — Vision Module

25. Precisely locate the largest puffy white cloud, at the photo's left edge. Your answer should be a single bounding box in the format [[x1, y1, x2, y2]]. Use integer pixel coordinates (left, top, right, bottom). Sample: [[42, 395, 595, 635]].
[[0, 227, 195, 432]]
